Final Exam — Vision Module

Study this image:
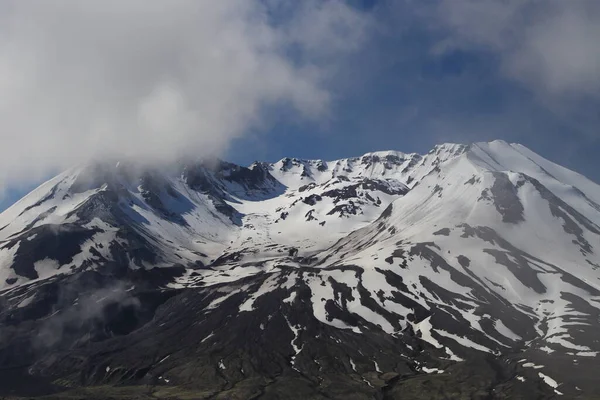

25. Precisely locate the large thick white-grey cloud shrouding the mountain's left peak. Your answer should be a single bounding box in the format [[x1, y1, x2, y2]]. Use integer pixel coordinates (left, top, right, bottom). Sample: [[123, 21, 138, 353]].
[[0, 0, 369, 187]]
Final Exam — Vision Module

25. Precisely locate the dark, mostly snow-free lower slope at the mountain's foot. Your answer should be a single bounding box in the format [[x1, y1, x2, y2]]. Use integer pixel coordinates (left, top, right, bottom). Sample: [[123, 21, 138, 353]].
[[0, 269, 564, 399]]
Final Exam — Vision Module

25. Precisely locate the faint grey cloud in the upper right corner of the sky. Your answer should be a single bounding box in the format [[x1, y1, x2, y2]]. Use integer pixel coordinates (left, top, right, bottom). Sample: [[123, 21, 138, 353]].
[[432, 0, 600, 98]]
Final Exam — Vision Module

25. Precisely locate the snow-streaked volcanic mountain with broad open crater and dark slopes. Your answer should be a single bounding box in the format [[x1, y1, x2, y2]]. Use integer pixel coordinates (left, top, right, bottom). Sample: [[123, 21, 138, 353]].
[[0, 141, 600, 399]]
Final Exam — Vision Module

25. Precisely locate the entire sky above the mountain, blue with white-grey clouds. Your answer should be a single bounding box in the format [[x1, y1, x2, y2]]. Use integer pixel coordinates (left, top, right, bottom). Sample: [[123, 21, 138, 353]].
[[0, 0, 600, 210]]
